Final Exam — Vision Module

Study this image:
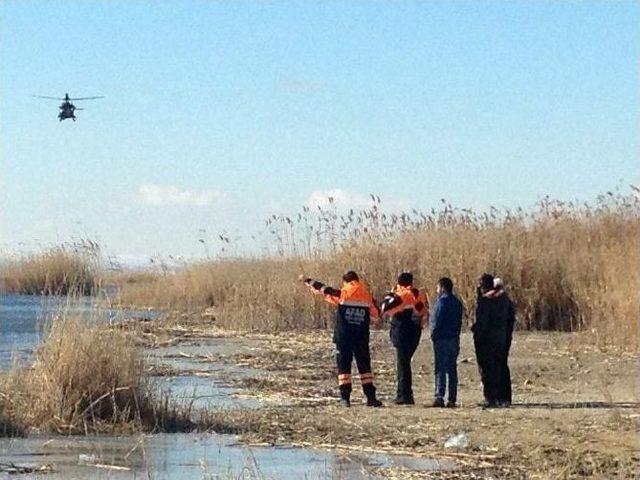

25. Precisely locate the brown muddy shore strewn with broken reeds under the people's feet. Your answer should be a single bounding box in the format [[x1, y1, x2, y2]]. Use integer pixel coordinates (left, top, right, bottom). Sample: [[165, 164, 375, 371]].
[[136, 316, 640, 479]]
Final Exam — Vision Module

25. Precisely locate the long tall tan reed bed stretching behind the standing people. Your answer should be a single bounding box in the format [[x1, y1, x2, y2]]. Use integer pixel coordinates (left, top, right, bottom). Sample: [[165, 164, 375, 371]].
[[120, 187, 640, 349]]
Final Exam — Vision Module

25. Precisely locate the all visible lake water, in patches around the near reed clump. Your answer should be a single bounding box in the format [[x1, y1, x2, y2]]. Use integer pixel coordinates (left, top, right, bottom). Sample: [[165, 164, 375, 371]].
[[0, 295, 455, 480]]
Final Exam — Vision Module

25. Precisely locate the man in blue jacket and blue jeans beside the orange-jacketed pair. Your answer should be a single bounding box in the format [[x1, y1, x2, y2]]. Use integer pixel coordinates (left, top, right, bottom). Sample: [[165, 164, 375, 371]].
[[430, 277, 463, 408]]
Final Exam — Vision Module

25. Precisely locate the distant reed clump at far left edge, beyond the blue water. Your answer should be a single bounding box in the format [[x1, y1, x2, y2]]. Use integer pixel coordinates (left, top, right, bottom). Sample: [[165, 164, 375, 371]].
[[0, 240, 100, 295]]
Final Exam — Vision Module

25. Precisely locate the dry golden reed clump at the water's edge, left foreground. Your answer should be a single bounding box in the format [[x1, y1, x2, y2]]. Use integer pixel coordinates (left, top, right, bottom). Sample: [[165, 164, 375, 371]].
[[0, 315, 193, 435]]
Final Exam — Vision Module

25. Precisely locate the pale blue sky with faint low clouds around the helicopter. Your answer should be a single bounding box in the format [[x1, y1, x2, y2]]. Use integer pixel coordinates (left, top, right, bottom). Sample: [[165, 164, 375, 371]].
[[0, 0, 640, 258]]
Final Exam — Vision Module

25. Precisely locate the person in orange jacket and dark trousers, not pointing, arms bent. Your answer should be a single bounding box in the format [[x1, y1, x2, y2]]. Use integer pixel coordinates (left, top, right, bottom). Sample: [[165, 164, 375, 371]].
[[382, 272, 429, 405]]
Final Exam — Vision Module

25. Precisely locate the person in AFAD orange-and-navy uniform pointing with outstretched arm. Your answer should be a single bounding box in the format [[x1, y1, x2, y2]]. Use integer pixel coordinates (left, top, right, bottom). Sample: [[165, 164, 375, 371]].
[[300, 271, 382, 407]]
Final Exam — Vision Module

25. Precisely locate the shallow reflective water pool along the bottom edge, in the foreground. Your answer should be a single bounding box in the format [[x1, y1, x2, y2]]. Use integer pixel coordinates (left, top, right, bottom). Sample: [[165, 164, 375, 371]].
[[0, 433, 455, 480]]
